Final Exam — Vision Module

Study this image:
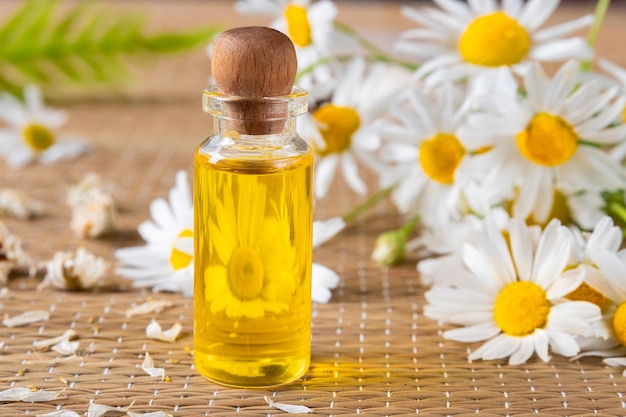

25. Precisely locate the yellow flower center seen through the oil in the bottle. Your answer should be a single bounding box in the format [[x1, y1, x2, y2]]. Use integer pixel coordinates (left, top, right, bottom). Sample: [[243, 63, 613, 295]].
[[228, 246, 264, 300]]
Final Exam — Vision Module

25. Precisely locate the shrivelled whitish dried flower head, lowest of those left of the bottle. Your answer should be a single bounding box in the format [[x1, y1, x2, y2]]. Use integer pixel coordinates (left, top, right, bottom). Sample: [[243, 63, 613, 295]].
[[37, 248, 108, 290]]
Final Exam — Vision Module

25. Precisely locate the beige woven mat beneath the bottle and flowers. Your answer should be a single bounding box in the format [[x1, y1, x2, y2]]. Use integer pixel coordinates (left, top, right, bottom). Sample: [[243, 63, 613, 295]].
[[0, 0, 626, 417]]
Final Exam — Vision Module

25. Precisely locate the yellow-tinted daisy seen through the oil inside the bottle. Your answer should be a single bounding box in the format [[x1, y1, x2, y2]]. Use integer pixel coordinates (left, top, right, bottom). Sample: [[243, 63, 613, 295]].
[[198, 174, 298, 318]]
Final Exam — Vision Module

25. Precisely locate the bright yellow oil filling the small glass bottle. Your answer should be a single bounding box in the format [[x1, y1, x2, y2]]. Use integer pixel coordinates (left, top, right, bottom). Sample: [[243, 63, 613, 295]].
[[194, 146, 313, 387]]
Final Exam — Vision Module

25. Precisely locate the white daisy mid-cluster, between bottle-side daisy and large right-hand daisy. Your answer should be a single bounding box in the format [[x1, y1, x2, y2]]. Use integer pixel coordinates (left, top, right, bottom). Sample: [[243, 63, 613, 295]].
[[378, 79, 487, 227]]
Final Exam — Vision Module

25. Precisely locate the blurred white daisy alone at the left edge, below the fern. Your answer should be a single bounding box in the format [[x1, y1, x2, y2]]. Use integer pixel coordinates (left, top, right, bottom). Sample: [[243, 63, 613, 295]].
[[0, 85, 89, 168]]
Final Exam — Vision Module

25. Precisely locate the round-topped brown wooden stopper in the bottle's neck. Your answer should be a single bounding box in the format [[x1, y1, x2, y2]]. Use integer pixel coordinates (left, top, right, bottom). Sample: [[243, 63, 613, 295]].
[[211, 26, 298, 135]]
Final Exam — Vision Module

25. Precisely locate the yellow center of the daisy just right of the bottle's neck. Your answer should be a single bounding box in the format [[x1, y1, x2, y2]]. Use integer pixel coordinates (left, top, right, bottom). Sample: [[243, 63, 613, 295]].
[[313, 104, 361, 155]]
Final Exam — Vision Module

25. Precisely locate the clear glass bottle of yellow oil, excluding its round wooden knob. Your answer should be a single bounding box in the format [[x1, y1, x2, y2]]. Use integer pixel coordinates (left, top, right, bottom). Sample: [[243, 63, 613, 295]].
[[194, 28, 313, 387]]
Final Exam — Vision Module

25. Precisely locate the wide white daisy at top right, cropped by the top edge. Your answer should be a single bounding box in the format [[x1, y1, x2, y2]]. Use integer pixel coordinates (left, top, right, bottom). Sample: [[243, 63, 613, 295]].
[[397, 0, 593, 85]]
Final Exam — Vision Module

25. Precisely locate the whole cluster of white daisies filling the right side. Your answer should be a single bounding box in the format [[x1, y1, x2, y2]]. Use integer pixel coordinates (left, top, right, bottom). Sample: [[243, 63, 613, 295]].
[[236, 0, 626, 363]]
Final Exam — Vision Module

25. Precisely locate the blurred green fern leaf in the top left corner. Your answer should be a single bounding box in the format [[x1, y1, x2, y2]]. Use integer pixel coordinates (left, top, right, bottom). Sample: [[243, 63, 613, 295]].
[[0, 0, 219, 93]]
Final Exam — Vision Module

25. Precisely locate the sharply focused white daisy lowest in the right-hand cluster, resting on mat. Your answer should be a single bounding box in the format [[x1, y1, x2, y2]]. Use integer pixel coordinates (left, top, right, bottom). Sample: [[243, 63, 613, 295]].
[[424, 219, 600, 365]]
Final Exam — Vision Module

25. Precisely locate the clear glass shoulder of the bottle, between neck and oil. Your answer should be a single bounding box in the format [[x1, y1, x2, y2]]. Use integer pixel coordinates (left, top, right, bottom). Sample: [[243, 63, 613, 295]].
[[195, 134, 313, 174]]
